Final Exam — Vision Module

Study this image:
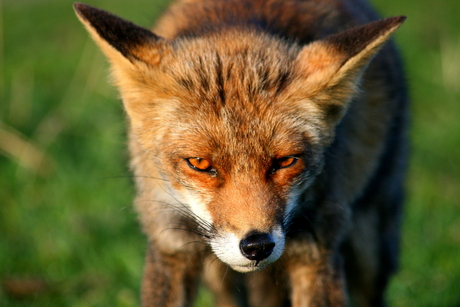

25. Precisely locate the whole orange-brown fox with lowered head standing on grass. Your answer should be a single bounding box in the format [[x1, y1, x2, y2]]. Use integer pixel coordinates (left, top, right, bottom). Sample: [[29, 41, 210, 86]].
[[74, 0, 409, 307]]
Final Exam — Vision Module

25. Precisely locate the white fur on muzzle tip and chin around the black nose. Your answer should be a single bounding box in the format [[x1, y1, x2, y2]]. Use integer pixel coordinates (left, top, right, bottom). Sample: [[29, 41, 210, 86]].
[[211, 225, 285, 273]]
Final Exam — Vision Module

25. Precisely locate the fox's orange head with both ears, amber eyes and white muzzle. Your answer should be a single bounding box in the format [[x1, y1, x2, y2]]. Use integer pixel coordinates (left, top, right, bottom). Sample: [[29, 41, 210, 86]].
[[75, 4, 405, 272]]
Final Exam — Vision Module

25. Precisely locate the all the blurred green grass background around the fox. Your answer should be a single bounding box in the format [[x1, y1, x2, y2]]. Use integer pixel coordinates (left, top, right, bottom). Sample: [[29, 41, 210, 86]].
[[0, 0, 460, 307]]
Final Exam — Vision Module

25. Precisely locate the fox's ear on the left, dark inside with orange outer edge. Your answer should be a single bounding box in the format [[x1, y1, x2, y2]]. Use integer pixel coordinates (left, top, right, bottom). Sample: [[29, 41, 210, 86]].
[[74, 3, 171, 126]]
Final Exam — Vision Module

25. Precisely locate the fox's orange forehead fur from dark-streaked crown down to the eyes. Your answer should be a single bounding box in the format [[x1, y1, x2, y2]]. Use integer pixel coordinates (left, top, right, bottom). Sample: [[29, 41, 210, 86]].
[[135, 31, 328, 155]]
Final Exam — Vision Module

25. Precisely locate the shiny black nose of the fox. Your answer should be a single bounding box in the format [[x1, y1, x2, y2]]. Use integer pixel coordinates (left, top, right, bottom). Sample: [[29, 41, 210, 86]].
[[240, 232, 275, 261]]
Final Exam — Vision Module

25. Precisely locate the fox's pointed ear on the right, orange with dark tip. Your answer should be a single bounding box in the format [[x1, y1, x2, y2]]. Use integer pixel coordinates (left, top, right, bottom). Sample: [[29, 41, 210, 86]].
[[297, 16, 406, 123]]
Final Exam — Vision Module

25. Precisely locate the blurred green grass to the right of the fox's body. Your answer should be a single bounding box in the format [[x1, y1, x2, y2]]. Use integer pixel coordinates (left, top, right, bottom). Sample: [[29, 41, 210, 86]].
[[377, 0, 460, 307]]
